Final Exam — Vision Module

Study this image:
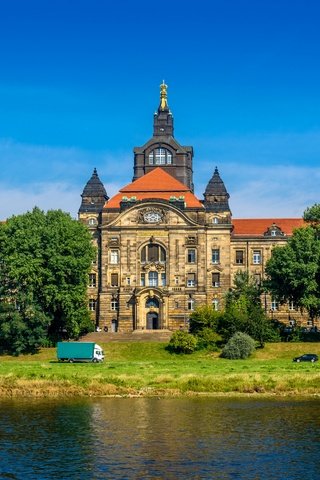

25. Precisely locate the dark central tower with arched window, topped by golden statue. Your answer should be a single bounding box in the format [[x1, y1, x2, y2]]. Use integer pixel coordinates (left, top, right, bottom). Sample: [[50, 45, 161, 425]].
[[132, 82, 193, 191]]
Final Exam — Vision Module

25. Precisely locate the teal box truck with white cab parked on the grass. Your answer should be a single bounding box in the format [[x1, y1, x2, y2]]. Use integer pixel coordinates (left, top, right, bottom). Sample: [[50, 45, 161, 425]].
[[57, 342, 104, 363]]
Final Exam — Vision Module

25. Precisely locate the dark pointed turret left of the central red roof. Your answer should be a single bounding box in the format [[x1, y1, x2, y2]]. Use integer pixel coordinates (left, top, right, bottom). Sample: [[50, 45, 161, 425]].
[[79, 168, 109, 214]]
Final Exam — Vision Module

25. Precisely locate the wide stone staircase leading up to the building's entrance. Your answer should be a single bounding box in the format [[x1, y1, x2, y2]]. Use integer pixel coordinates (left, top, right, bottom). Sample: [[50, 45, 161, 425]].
[[79, 330, 172, 344]]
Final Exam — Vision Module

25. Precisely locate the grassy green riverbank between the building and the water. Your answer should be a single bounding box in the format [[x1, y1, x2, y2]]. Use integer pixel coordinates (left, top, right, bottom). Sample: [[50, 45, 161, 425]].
[[0, 342, 320, 398]]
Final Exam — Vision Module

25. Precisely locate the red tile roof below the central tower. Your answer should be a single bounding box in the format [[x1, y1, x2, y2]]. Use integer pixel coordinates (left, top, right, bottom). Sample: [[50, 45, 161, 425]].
[[105, 167, 204, 209]]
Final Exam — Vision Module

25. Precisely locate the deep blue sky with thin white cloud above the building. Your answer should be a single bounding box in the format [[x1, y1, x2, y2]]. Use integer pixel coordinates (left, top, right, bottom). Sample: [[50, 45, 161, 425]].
[[0, 0, 320, 218]]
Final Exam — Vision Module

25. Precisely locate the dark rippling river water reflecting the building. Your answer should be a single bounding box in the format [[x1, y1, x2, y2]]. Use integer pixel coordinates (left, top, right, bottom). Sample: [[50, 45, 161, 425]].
[[0, 398, 320, 480]]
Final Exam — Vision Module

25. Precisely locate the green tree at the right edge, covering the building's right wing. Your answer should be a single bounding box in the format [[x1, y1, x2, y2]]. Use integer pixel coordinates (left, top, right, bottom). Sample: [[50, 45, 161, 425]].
[[266, 223, 320, 321]]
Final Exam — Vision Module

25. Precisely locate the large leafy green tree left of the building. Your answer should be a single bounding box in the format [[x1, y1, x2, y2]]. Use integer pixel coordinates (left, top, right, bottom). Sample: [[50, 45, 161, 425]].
[[0, 208, 95, 352]]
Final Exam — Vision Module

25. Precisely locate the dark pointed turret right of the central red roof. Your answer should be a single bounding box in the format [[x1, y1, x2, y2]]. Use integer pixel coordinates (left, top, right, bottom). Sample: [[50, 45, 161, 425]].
[[203, 167, 231, 214]]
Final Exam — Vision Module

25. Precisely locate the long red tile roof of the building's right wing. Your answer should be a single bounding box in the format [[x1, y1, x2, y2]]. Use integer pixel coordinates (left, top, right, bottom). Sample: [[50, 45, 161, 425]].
[[232, 218, 305, 237]]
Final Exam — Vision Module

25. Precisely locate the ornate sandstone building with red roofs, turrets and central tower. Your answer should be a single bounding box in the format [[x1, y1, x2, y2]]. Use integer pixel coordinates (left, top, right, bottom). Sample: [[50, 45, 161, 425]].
[[79, 83, 303, 331]]
